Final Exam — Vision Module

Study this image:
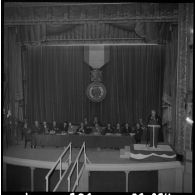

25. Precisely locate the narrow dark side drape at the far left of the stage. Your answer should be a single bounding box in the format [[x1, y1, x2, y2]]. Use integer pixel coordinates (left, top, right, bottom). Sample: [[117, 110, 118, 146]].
[[3, 27, 23, 120]]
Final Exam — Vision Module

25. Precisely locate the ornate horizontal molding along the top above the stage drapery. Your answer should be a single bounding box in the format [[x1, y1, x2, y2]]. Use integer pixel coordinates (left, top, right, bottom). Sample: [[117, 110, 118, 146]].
[[4, 3, 178, 25]]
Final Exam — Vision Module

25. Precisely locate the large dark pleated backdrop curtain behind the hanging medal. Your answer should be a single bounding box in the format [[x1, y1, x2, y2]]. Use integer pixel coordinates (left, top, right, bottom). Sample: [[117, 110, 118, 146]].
[[23, 45, 164, 124]]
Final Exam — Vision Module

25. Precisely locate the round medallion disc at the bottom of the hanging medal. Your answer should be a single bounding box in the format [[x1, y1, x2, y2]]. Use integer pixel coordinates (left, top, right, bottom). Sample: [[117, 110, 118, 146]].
[[86, 82, 106, 102]]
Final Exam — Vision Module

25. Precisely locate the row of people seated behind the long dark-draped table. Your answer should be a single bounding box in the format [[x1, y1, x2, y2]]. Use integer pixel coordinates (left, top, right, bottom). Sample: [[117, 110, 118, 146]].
[[3, 117, 144, 147]]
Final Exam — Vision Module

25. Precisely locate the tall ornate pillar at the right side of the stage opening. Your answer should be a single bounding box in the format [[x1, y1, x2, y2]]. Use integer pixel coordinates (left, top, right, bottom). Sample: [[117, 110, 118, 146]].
[[174, 3, 193, 155]]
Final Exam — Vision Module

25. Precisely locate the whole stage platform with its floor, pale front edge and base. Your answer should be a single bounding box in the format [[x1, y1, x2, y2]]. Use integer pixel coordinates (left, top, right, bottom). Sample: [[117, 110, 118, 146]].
[[3, 143, 183, 192]]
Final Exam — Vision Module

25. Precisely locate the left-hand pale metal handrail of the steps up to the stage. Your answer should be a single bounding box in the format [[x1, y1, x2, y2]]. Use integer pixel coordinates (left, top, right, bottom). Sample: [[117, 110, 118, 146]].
[[45, 143, 72, 192]]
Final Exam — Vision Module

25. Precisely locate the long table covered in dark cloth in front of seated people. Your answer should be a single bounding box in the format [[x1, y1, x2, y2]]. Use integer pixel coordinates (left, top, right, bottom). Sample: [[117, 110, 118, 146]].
[[34, 135, 135, 148]]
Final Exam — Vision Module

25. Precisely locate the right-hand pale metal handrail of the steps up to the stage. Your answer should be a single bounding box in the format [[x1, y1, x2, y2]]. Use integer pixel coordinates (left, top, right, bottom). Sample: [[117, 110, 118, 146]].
[[67, 142, 86, 192]]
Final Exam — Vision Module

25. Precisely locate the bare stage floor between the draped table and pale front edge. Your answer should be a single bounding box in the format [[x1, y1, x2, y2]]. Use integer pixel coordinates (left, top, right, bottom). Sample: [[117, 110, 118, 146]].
[[3, 142, 172, 164]]
